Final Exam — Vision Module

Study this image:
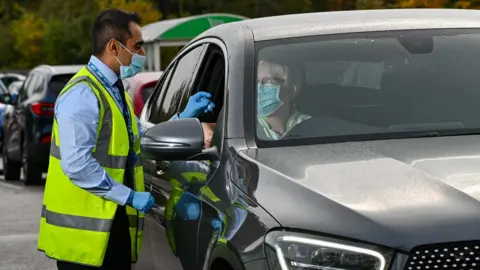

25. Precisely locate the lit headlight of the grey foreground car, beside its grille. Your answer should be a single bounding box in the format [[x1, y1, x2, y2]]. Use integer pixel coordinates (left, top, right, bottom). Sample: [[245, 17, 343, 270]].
[[265, 231, 393, 270]]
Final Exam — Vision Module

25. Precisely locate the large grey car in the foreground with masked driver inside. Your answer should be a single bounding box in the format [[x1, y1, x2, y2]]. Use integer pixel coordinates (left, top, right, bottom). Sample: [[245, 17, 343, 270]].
[[141, 9, 480, 270]]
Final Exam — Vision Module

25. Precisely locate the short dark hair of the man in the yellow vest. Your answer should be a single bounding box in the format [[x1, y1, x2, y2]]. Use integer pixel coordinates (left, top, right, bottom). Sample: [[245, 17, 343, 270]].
[[90, 9, 140, 56]]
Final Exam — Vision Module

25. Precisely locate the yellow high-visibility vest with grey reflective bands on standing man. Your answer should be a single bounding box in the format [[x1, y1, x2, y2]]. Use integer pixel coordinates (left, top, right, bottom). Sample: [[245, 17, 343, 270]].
[[38, 67, 145, 266]]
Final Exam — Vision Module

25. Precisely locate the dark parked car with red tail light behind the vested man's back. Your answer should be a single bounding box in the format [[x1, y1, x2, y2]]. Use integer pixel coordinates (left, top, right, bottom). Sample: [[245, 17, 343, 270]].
[[2, 65, 82, 185]]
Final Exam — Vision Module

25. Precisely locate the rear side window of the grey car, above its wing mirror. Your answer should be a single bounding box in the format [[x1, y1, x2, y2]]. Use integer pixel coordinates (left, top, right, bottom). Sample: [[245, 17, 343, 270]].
[[157, 45, 205, 123]]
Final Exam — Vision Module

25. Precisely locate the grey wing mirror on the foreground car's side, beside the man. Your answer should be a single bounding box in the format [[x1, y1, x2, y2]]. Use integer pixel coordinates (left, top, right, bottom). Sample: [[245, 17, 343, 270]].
[[140, 118, 218, 161]]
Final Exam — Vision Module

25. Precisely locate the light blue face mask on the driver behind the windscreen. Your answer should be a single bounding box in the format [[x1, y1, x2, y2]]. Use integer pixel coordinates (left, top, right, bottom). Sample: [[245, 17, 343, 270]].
[[257, 83, 283, 116]]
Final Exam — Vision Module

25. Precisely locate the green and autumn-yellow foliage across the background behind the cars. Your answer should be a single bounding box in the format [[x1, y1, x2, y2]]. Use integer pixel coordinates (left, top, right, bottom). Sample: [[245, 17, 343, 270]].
[[0, 0, 480, 69]]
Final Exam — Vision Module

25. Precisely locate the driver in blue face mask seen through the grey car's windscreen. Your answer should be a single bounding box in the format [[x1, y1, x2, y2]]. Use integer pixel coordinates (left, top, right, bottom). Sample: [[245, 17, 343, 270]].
[[257, 60, 311, 140]]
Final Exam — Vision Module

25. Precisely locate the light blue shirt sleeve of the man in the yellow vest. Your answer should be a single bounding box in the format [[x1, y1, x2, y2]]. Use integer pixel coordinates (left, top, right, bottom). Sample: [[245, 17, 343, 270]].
[[55, 83, 132, 205]]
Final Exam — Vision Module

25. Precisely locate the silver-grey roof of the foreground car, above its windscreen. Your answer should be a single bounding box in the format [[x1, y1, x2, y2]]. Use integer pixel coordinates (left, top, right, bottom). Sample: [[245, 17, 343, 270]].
[[196, 9, 480, 41]]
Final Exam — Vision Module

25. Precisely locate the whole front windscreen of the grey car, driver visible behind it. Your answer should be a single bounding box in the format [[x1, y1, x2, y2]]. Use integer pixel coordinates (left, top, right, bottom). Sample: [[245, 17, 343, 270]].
[[254, 29, 480, 145]]
